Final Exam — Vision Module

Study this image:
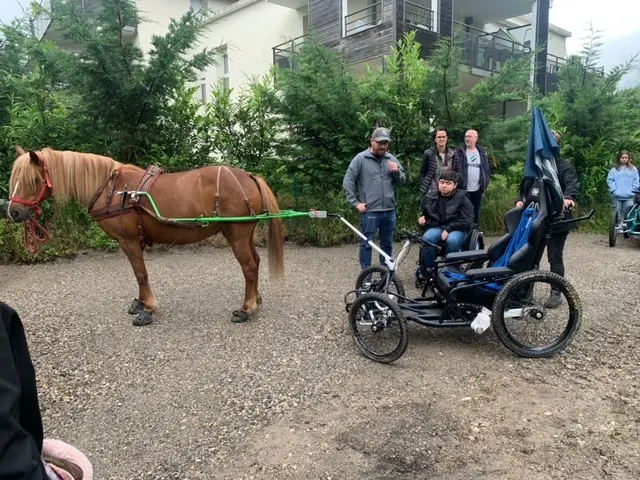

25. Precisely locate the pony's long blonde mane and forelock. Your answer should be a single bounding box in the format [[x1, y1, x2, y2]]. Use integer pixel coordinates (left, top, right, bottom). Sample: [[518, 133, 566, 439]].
[[10, 148, 144, 205]]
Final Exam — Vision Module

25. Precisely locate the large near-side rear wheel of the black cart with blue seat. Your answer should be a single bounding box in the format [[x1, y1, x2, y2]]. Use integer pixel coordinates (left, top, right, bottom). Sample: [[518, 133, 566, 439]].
[[491, 270, 581, 358]]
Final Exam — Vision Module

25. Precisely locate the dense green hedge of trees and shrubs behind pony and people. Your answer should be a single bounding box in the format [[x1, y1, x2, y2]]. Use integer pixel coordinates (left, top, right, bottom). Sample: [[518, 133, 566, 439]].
[[0, 6, 640, 262]]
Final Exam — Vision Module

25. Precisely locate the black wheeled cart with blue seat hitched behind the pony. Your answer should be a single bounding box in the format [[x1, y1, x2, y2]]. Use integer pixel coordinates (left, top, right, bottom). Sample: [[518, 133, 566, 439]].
[[341, 180, 594, 363]]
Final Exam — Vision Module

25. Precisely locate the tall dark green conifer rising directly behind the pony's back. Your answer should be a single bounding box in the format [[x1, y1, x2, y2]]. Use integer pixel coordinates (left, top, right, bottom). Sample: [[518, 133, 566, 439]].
[[40, 0, 218, 163]]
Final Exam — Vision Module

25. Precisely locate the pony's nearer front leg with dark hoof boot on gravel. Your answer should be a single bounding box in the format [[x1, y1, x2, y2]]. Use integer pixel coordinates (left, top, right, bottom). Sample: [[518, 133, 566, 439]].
[[118, 238, 158, 327]]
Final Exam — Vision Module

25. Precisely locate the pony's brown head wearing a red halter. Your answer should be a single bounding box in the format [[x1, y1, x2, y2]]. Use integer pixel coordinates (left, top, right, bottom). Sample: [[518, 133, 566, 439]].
[[7, 147, 53, 223]]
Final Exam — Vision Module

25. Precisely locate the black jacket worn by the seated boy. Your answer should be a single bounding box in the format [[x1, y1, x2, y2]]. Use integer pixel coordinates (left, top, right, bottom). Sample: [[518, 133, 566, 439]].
[[422, 188, 473, 232]]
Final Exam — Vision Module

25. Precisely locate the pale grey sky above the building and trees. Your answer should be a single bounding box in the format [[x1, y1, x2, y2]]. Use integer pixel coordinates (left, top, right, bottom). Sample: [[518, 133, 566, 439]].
[[0, 0, 640, 54]]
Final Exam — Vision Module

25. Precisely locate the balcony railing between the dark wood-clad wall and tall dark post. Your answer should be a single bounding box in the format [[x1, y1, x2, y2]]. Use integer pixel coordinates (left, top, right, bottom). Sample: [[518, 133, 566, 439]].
[[454, 22, 531, 72]]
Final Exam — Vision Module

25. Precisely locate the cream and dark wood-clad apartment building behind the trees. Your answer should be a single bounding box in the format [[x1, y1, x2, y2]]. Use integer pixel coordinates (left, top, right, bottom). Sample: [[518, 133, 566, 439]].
[[35, 0, 571, 102]]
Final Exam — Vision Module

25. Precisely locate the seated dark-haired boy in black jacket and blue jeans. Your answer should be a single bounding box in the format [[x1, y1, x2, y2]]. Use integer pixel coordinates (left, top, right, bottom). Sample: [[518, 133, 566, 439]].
[[417, 170, 473, 281]]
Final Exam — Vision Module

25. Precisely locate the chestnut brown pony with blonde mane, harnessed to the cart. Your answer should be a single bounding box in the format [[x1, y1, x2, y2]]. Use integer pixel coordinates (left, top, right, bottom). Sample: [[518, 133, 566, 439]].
[[8, 147, 284, 326]]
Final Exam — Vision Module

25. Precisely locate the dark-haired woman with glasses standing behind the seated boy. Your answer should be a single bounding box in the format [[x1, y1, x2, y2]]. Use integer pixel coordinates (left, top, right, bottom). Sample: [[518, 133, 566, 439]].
[[420, 127, 464, 204]]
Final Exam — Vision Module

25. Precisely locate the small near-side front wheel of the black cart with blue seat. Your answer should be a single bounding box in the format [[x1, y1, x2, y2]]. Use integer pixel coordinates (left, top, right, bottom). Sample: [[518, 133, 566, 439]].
[[349, 293, 409, 363]]
